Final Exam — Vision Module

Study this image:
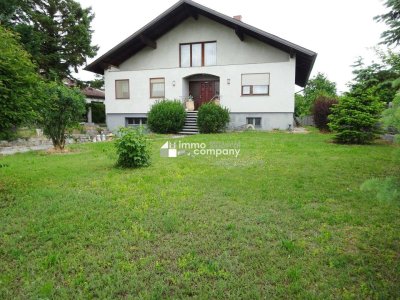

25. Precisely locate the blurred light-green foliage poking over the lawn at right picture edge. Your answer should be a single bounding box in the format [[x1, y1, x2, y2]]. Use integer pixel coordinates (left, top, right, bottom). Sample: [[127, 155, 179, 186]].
[[360, 177, 400, 201]]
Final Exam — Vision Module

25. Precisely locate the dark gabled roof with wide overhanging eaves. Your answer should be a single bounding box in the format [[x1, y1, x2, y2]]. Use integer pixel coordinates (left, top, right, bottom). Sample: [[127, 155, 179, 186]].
[[85, 0, 317, 87]]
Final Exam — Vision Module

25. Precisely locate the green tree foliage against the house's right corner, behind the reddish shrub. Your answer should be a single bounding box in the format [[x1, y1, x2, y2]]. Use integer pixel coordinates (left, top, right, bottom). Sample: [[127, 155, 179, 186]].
[[295, 73, 337, 117]]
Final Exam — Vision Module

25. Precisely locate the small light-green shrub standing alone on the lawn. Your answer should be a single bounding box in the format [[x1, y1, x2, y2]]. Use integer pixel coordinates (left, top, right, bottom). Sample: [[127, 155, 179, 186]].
[[115, 128, 150, 168]]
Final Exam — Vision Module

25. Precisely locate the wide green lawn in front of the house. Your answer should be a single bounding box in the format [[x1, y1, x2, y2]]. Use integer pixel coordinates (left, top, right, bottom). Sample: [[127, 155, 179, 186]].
[[0, 132, 400, 299]]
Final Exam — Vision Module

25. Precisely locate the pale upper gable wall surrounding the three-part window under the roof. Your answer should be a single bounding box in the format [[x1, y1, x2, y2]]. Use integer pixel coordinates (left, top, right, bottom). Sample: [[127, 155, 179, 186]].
[[119, 16, 289, 71]]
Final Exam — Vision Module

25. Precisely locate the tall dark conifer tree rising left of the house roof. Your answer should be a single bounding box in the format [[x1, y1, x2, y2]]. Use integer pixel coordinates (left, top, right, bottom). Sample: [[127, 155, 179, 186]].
[[2, 0, 98, 81]]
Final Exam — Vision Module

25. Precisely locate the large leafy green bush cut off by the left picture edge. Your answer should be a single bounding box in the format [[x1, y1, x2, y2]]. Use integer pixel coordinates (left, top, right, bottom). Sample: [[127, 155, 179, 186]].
[[0, 26, 42, 138]]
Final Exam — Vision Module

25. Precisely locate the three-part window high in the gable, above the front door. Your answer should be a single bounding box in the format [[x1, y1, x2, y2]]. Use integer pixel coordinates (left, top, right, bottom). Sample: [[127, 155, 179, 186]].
[[179, 42, 217, 68]]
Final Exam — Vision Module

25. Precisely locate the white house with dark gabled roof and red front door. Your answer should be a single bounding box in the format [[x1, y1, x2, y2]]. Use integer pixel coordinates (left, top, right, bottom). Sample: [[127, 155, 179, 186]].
[[85, 0, 317, 130]]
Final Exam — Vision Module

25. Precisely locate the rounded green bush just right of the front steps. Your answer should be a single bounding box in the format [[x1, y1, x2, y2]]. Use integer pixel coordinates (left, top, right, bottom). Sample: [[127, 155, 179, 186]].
[[197, 102, 229, 133]]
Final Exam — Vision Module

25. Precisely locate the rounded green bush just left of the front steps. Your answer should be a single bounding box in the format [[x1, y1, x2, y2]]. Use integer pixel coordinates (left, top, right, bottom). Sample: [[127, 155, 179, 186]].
[[147, 100, 186, 133]]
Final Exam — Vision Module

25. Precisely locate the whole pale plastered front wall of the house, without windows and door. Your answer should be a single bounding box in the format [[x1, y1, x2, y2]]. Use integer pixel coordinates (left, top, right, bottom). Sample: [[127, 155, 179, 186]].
[[105, 16, 295, 130]]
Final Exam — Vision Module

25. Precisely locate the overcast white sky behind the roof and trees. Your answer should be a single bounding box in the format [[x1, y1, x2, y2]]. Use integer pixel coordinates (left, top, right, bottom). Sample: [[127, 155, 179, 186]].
[[78, 0, 387, 92]]
